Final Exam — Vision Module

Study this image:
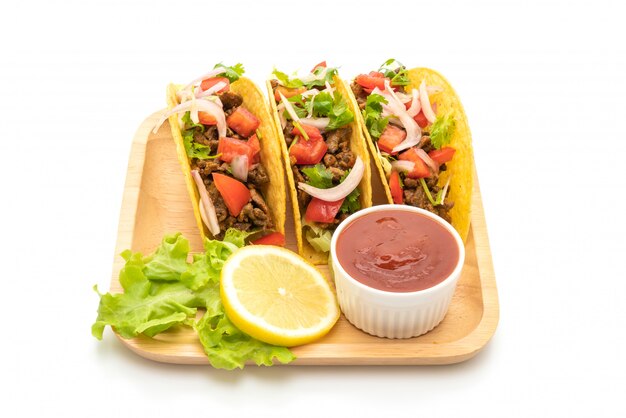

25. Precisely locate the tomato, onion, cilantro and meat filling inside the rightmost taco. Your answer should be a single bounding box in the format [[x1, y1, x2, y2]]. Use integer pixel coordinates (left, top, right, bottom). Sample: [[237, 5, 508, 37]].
[[350, 59, 455, 222]]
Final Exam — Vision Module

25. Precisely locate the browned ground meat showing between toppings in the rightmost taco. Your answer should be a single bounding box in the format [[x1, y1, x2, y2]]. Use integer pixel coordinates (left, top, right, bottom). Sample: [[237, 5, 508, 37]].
[[350, 81, 454, 222]]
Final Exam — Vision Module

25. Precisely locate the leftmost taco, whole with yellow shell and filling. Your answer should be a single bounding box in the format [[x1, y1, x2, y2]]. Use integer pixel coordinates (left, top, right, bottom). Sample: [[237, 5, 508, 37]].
[[155, 64, 286, 245]]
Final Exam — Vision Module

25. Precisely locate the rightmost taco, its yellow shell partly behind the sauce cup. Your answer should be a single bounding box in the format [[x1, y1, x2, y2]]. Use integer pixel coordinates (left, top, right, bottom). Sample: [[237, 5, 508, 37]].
[[350, 59, 474, 240]]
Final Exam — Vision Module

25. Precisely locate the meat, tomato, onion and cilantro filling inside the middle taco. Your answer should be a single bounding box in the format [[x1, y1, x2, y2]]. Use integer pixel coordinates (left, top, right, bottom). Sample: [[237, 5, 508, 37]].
[[270, 62, 364, 252]]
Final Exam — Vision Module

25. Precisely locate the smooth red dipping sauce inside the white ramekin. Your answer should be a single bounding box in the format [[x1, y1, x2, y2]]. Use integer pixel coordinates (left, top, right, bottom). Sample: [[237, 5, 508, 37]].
[[336, 209, 459, 292]]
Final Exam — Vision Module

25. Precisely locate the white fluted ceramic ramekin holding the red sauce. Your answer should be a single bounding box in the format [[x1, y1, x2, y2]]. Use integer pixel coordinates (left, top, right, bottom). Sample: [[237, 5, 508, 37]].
[[330, 205, 465, 338]]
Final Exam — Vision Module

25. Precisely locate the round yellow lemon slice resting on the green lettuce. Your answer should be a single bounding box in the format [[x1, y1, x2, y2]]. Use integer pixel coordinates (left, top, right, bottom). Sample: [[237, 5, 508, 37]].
[[220, 245, 339, 347]]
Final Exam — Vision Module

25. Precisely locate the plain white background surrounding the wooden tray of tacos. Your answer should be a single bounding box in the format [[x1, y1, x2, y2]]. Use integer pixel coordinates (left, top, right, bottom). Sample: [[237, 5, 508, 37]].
[[0, 0, 626, 417]]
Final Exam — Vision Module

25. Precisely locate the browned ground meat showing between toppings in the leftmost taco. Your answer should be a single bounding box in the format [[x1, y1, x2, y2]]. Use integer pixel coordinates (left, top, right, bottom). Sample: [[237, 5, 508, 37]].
[[186, 92, 274, 239]]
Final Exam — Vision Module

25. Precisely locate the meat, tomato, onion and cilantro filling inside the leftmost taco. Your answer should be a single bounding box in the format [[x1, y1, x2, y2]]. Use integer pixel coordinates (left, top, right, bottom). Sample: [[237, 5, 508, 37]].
[[155, 64, 276, 245]]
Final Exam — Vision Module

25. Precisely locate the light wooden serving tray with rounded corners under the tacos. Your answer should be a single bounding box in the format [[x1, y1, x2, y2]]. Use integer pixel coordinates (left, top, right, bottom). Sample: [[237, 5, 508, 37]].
[[111, 113, 499, 365]]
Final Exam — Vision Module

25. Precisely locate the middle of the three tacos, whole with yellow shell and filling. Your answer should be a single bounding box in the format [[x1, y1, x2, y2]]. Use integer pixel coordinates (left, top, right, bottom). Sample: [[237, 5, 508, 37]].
[[267, 62, 372, 264]]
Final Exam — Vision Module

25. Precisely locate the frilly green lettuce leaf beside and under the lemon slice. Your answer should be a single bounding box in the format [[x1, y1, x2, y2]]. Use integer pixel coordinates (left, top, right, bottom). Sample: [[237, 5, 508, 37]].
[[91, 229, 295, 370]]
